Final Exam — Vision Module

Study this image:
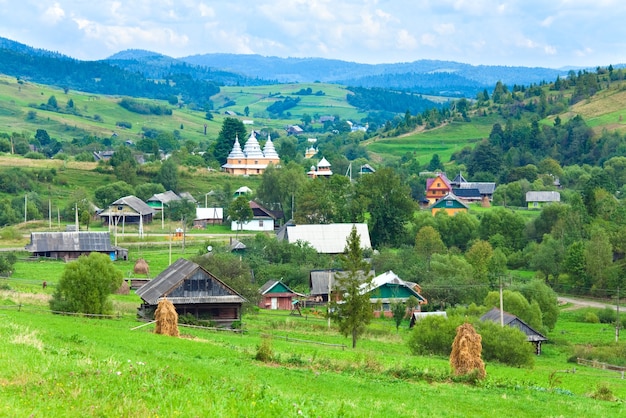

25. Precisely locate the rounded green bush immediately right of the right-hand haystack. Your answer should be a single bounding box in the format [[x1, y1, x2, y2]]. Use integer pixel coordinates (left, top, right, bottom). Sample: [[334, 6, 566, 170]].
[[475, 321, 535, 367]]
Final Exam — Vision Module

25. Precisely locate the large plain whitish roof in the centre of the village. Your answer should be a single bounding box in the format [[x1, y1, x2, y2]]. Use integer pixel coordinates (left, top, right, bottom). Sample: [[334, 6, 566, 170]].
[[277, 223, 372, 254]]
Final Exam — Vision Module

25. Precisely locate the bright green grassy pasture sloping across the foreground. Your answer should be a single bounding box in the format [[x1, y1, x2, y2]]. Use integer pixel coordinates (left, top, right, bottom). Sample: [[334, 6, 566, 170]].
[[0, 250, 626, 417]]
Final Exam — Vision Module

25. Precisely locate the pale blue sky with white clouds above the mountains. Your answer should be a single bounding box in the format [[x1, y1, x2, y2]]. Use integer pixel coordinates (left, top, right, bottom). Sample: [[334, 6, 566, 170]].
[[0, 0, 626, 68]]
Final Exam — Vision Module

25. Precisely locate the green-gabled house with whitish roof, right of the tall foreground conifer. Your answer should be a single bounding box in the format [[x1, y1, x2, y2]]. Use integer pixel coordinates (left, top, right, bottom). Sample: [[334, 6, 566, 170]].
[[363, 270, 427, 318]]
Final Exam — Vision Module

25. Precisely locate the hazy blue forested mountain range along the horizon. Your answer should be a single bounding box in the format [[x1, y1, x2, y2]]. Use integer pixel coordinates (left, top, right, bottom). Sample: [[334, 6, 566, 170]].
[[0, 38, 568, 98]]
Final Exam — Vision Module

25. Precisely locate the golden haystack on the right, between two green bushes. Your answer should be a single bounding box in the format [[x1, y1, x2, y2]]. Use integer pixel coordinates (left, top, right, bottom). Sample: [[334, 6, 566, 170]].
[[450, 322, 486, 379]]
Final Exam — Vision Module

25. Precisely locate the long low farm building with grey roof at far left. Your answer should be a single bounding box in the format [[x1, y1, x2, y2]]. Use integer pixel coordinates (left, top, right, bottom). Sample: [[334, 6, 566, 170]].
[[24, 231, 128, 260]]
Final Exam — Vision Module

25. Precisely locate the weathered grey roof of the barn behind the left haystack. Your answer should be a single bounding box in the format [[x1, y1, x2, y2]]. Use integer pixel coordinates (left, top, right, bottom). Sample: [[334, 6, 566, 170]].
[[136, 258, 246, 305]]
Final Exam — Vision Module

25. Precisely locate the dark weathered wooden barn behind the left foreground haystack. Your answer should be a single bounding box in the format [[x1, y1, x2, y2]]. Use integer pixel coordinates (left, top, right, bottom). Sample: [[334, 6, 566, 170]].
[[137, 258, 246, 327]]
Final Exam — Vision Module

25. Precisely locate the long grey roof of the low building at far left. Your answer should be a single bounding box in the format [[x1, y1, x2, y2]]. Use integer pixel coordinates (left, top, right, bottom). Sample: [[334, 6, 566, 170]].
[[24, 232, 114, 252]]
